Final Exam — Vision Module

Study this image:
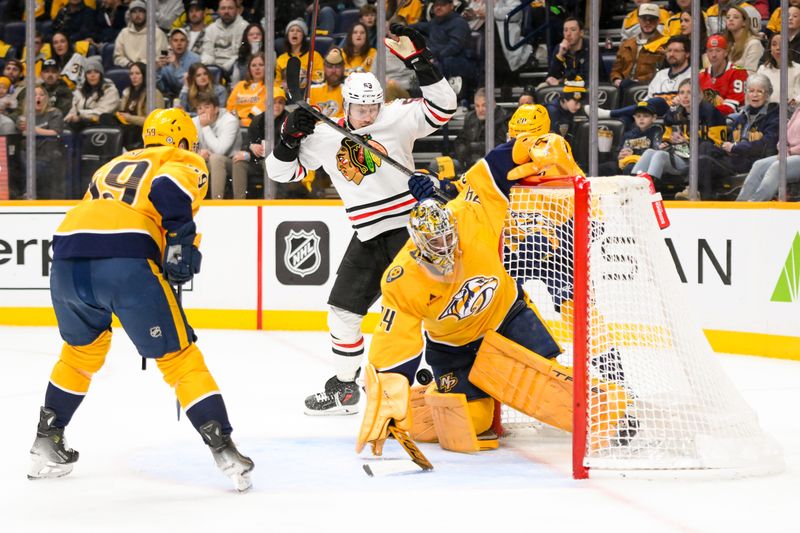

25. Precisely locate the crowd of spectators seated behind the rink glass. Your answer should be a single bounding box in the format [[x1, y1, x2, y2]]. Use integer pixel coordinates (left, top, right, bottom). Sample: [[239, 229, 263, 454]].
[[0, 0, 800, 200]]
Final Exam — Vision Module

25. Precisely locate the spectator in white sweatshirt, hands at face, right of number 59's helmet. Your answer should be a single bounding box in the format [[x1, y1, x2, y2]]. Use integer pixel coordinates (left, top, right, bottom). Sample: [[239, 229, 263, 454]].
[[192, 94, 242, 200]]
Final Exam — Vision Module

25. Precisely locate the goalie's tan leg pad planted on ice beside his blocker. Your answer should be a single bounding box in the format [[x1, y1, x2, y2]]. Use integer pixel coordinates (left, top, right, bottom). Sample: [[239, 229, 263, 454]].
[[425, 386, 497, 453]]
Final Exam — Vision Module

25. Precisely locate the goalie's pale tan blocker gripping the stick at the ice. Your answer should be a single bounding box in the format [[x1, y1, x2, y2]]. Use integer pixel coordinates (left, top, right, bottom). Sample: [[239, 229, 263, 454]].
[[356, 364, 412, 455]]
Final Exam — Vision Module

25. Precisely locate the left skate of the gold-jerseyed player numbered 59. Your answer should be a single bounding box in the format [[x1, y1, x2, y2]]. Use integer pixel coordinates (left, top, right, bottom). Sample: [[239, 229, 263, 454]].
[[28, 407, 78, 479]]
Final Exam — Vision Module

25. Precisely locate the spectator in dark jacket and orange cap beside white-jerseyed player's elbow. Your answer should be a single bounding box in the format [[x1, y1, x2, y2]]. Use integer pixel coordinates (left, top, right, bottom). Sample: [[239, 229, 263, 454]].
[[233, 87, 294, 199]]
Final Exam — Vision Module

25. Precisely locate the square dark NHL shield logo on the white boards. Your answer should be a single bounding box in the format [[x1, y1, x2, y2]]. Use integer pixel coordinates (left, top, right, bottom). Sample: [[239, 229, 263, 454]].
[[275, 220, 330, 285]]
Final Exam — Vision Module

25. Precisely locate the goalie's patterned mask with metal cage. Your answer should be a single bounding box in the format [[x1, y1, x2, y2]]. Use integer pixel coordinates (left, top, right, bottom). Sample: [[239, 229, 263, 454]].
[[408, 198, 458, 275]]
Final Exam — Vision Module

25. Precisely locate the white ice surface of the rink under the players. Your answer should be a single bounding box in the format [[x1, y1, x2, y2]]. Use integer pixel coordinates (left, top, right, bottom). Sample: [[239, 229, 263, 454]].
[[0, 327, 800, 533]]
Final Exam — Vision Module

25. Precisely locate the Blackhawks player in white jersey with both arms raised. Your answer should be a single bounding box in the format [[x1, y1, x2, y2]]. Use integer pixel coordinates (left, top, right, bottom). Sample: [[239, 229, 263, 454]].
[[266, 24, 457, 415]]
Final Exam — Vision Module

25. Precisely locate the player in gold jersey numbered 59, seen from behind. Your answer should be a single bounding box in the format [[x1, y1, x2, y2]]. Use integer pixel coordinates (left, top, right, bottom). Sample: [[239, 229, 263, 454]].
[[28, 109, 253, 490]]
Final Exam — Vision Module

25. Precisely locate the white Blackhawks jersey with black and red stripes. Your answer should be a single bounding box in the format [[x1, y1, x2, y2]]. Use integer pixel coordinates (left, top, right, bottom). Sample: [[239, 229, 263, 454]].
[[265, 79, 456, 241]]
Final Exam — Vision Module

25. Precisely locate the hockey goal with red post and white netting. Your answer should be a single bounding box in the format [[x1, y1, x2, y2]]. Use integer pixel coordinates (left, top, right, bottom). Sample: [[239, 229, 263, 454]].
[[502, 176, 782, 478]]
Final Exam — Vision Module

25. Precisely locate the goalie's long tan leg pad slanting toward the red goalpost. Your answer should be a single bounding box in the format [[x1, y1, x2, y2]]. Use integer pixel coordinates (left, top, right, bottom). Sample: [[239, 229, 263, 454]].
[[469, 331, 572, 431]]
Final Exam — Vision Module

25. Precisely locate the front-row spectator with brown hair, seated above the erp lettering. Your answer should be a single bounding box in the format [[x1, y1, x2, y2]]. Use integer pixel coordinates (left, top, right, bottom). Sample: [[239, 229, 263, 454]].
[[17, 85, 66, 200]]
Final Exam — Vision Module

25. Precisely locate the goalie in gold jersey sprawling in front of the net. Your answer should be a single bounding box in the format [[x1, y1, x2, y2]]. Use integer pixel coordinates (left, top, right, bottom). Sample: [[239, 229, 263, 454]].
[[356, 110, 635, 455]]
